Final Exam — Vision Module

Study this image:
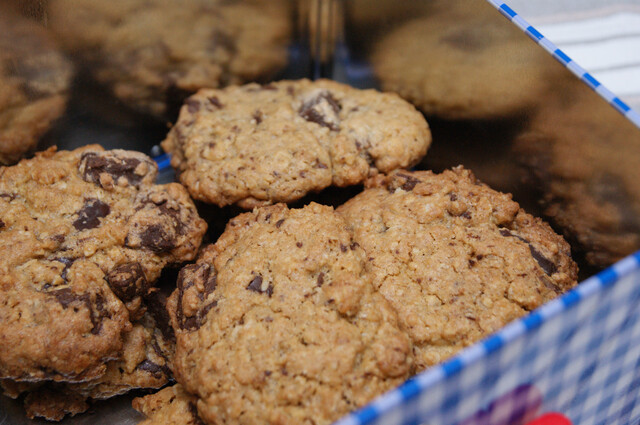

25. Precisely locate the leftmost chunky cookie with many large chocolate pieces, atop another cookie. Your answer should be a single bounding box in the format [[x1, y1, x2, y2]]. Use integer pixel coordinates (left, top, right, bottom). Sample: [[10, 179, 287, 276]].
[[0, 145, 206, 382]]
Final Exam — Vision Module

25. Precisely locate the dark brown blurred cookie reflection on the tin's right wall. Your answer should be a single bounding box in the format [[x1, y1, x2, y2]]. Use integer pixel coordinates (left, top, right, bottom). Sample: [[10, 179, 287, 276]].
[[514, 84, 640, 268]]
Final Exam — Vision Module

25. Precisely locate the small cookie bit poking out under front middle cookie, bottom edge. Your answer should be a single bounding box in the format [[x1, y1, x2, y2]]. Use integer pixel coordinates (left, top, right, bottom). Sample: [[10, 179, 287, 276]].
[[132, 384, 204, 425]]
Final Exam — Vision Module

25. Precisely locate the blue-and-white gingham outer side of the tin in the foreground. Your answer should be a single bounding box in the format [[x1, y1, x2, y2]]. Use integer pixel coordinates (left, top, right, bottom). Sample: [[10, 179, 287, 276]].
[[336, 252, 640, 425]]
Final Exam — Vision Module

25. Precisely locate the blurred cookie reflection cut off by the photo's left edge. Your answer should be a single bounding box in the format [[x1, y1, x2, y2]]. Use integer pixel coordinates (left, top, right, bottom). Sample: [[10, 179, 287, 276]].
[[0, 7, 73, 164]]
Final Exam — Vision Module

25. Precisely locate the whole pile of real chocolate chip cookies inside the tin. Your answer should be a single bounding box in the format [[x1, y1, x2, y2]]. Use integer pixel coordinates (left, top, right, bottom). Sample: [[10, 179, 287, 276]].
[[0, 74, 577, 424]]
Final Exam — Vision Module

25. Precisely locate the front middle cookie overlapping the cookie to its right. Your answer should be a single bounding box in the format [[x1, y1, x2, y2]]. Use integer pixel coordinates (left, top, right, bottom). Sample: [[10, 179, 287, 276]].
[[168, 203, 413, 425]]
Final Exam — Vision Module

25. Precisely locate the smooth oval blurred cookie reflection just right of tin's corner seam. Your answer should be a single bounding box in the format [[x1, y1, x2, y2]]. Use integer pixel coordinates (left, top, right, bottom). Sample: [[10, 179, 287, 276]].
[[371, 1, 555, 119]]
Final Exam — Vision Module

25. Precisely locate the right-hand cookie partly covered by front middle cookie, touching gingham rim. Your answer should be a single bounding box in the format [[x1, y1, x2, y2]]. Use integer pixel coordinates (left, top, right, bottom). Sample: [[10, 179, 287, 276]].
[[337, 167, 577, 370]]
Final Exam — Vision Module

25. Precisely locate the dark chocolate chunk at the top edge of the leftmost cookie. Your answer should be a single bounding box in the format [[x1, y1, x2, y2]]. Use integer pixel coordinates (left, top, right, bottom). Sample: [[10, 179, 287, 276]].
[[79, 152, 144, 187]]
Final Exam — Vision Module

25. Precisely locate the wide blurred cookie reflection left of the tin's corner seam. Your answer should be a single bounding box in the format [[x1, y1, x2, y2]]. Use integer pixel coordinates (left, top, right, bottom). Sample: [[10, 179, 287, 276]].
[[49, 0, 290, 119]]
